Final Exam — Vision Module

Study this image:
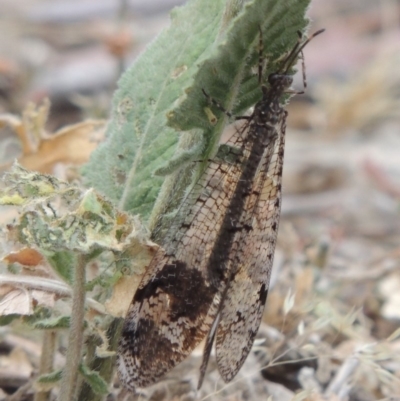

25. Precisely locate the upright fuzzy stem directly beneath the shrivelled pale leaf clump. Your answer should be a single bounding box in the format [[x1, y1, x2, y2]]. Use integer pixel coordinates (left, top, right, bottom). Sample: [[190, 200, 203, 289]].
[[59, 255, 86, 401]]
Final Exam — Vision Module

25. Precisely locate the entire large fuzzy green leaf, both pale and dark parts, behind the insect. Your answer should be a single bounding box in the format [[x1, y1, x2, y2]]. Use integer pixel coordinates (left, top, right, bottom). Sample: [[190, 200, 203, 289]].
[[83, 0, 310, 229]]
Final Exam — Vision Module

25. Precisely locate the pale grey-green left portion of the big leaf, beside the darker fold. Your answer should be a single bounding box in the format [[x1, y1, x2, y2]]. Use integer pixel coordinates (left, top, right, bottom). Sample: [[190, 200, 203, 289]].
[[83, 0, 224, 217]]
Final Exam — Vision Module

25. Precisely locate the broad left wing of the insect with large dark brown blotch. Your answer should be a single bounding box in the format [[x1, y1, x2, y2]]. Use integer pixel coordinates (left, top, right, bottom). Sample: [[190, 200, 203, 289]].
[[117, 125, 252, 390]]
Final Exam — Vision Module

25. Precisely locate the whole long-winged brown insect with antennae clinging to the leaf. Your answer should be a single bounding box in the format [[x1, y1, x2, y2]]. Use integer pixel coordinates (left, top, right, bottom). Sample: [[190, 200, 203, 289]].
[[117, 30, 323, 390]]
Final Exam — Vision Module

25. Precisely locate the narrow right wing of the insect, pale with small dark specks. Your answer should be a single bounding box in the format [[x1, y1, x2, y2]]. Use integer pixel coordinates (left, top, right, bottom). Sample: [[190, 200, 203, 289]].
[[216, 110, 286, 382]]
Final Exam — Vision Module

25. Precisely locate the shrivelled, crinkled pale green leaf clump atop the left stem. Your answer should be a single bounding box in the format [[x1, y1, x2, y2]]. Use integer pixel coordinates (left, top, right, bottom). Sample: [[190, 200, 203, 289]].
[[4, 164, 145, 255]]
